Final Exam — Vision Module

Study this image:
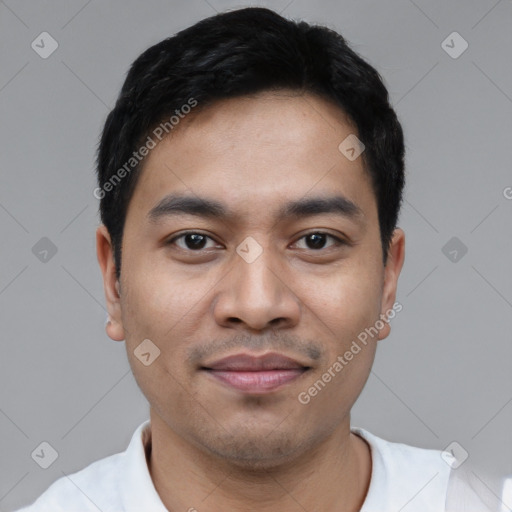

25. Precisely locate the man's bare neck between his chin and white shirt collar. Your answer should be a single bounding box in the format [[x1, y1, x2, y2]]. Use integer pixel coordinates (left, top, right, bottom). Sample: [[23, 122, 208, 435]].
[[148, 409, 371, 512]]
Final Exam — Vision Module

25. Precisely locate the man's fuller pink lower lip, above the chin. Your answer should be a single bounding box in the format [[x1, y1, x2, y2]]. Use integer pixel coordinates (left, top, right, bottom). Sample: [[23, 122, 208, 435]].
[[207, 368, 306, 393]]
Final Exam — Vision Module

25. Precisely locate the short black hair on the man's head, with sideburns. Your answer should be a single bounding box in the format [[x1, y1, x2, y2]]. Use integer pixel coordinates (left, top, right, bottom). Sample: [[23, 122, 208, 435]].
[[94, 7, 405, 278]]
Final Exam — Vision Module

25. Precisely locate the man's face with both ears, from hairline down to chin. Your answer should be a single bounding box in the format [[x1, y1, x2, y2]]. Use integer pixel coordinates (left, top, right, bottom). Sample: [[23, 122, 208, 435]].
[[97, 92, 404, 466]]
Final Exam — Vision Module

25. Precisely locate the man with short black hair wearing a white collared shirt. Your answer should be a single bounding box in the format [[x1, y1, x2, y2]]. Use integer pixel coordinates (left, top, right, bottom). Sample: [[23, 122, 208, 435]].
[[17, 8, 492, 512]]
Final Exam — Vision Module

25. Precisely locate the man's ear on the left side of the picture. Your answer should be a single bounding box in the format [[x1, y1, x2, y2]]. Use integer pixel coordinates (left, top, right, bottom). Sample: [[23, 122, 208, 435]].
[[96, 224, 125, 341]]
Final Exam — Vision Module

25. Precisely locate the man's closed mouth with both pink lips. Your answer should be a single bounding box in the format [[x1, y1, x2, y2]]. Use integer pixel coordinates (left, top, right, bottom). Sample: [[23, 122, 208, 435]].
[[201, 353, 311, 394]]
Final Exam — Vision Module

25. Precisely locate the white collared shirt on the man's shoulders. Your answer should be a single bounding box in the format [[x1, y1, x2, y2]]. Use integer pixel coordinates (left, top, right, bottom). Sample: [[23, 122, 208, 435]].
[[14, 420, 480, 512]]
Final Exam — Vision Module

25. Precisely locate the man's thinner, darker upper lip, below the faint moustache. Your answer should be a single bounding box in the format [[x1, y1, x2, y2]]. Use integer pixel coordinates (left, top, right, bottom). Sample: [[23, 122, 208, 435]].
[[203, 352, 309, 372]]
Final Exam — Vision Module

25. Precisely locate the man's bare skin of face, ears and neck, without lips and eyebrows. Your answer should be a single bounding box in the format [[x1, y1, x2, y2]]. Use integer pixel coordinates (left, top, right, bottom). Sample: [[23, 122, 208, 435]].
[[97, 91, 405, 512]]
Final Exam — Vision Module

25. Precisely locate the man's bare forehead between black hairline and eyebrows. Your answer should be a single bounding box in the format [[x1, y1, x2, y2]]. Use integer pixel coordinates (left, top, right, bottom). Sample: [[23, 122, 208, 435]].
[[129, 91, 376, 228]]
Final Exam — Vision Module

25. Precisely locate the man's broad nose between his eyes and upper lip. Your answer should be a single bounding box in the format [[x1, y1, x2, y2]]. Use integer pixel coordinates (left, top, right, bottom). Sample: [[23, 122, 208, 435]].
[[213, 250, 301, 331]]
